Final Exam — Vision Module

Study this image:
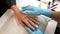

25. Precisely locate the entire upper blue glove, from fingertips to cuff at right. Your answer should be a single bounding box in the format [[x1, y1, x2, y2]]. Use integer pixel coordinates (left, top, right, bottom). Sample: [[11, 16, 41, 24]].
[[22, 5, 52, 17]]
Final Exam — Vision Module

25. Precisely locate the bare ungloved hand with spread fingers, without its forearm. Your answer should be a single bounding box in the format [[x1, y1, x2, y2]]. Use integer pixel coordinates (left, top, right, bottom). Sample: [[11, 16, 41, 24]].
[[17, 13, 38, 29]]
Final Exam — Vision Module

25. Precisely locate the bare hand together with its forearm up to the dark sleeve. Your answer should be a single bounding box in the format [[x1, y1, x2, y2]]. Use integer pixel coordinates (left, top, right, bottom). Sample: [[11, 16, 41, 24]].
[[11, 5, 38, 29]]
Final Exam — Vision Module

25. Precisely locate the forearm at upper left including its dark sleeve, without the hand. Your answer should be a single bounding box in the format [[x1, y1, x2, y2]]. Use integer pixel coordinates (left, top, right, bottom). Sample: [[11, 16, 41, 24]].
[[5, 0, 21, 17]]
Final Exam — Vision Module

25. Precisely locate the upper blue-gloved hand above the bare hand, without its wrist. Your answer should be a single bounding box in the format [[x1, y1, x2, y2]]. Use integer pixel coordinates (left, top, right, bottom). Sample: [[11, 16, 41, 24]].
[[22, 5, 40, 15]]
